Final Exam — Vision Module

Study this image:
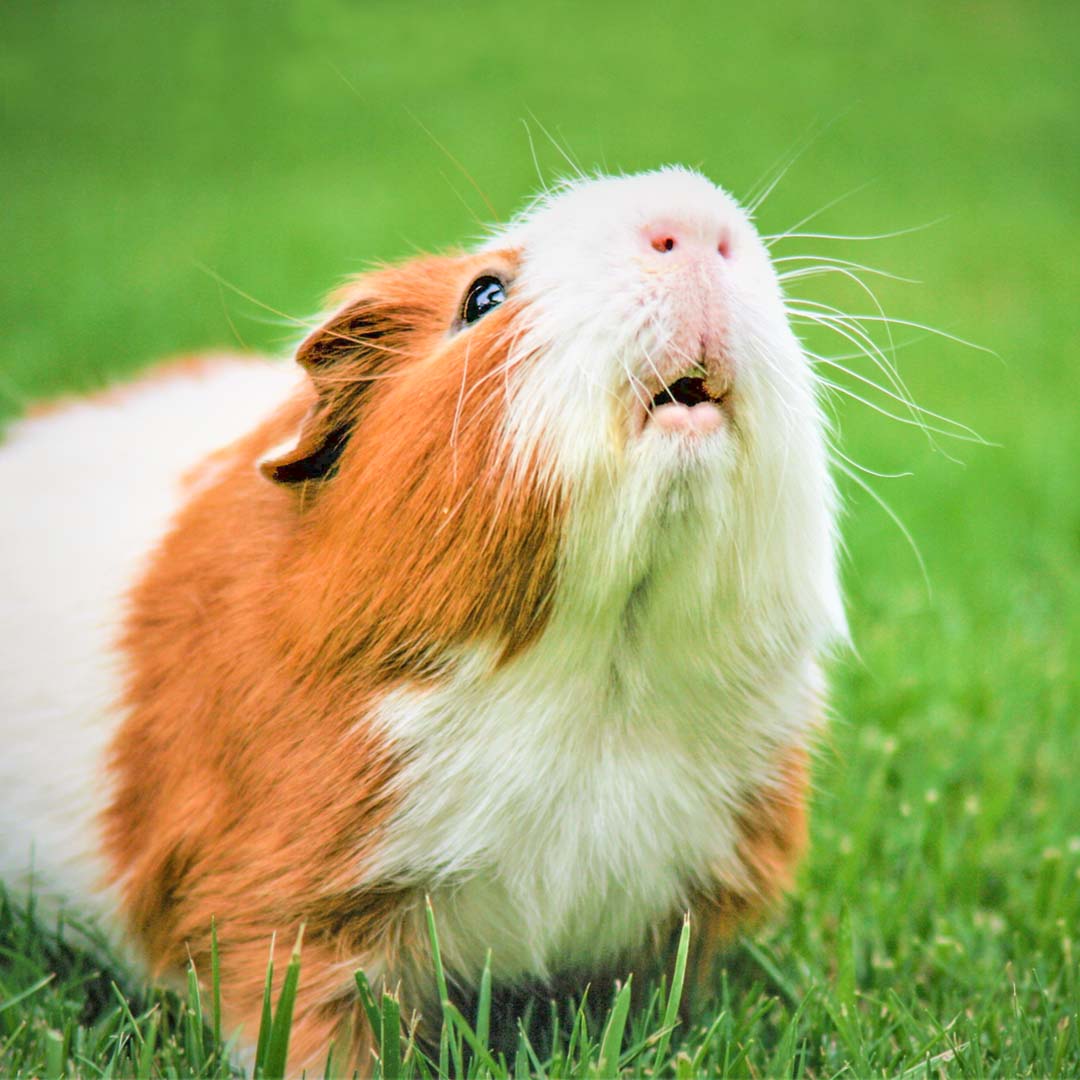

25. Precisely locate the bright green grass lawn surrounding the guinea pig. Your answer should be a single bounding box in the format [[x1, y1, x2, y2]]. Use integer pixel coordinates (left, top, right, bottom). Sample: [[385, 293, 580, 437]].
[[0, 0, 1080, 1078]]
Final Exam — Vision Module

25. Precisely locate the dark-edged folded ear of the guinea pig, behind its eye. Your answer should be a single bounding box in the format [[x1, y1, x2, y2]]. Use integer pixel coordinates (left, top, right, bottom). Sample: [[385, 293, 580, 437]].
[[258, 299, 401, 485]]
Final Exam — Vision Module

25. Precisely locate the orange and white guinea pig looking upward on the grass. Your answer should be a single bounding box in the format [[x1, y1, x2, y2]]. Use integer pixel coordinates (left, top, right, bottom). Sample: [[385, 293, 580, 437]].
[[0, 167, 847, 1068]]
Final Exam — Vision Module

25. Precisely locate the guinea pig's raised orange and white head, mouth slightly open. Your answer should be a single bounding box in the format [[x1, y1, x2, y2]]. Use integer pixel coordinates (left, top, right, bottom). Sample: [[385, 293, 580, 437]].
[[261, 170, 842, 671]]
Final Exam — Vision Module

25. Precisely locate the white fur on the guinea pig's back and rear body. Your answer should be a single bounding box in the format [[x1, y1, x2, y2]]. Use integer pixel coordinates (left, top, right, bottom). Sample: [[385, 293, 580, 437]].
[[0, 359, 297, 921]]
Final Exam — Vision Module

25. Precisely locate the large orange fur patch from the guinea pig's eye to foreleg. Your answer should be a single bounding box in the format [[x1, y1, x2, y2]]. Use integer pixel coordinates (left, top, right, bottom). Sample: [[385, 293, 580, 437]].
[[105, 253, 561, 1061]]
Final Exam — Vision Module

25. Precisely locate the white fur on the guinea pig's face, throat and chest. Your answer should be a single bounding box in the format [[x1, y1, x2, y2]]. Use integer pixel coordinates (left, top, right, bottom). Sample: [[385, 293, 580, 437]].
[[365, 170, 846, 977]]
